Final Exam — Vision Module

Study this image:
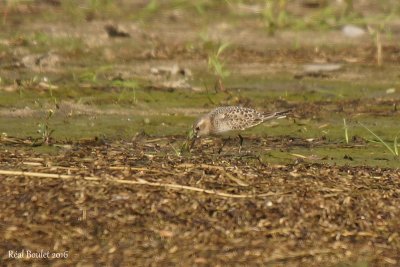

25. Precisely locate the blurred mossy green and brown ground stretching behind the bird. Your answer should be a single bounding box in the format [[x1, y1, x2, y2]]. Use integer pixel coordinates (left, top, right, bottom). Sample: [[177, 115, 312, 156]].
[[0, 0, 400, 144]]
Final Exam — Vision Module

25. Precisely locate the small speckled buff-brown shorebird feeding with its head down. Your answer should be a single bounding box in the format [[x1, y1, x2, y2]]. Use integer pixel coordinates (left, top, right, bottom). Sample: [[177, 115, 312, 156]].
[[192, 106, 290, 153]]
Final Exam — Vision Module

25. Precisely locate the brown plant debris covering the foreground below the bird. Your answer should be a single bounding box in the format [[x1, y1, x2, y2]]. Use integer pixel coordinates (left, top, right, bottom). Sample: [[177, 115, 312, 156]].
[[0, 137, 400, 266]]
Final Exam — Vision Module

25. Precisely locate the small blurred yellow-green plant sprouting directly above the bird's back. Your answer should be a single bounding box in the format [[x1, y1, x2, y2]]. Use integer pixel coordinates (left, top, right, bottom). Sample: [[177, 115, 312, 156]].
[[208, 43, 230, 90]]
